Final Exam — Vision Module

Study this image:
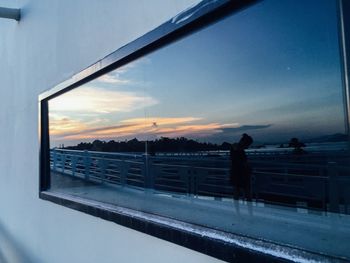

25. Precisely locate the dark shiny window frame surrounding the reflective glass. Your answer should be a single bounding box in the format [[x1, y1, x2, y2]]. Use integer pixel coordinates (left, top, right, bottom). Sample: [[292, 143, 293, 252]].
[[39, 0, 350, 262]]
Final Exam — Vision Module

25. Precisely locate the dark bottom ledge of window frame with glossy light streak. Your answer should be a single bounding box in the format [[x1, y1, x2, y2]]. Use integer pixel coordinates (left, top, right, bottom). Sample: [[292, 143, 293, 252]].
[[40, 191, 346, 262]]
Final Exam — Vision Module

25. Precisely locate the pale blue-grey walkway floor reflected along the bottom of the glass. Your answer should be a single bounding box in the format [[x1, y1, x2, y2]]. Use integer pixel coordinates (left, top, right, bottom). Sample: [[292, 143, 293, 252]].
[[52, 172, 350, 260]]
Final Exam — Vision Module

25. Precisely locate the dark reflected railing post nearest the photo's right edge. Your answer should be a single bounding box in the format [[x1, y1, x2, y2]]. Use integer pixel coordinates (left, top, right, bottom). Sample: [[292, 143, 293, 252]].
[[327, 162, 339, 212]]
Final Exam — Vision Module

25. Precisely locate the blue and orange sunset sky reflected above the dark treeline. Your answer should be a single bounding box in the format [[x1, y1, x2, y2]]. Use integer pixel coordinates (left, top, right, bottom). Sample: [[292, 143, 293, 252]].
[[49, 0, 344, 146]]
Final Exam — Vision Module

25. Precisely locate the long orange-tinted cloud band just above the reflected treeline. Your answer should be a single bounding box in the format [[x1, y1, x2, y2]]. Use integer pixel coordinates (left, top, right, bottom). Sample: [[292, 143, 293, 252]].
[[50, 110, 271, 142]]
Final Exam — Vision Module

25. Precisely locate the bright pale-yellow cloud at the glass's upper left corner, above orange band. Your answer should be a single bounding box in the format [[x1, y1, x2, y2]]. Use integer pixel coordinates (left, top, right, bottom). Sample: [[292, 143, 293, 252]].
[[49, 86, 158, 114]]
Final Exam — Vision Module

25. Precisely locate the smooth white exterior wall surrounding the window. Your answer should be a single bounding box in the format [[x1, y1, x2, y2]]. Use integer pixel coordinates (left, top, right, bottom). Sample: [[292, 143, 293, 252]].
[[0, 0, 223, 263]]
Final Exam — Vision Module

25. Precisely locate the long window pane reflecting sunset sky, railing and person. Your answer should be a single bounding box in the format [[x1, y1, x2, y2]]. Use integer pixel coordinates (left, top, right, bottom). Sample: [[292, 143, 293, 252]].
[[42, 0, 350, 259]]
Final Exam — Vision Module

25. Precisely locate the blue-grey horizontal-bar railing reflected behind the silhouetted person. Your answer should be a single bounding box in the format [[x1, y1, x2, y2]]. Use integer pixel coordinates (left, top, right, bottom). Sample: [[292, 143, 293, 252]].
[[50, 149, 350, 213]]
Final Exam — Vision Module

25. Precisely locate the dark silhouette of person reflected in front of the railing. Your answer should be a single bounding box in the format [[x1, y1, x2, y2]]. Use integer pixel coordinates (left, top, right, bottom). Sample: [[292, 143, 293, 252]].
[[230, 133, 253, 201]]
